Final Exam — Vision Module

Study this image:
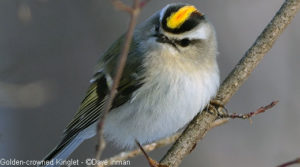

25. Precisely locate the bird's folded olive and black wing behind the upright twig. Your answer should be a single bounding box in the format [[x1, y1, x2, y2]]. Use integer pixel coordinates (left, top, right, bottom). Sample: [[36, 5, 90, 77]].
[[53, 36, 143, 153]]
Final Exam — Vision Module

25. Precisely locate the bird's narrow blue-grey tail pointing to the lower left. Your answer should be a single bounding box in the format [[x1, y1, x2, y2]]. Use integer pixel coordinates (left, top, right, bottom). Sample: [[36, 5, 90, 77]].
[[40, 133, 86, 167]]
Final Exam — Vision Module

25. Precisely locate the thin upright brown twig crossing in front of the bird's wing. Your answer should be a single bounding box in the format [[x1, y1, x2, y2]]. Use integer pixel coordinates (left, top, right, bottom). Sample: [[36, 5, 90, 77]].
[[96, 0, 140, 160]]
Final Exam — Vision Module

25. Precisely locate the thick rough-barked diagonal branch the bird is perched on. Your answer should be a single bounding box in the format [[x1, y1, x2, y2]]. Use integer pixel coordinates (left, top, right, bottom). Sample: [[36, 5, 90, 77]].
[[161, 0, 300, 167]]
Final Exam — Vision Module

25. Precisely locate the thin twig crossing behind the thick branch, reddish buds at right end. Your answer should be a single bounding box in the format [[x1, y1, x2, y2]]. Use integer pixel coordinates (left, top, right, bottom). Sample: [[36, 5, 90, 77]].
[[98, 101, 277, 167]]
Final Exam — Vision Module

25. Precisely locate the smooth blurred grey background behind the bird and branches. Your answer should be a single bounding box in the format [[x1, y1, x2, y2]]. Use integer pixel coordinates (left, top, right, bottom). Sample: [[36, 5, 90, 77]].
[[0, 0, 300, 167]]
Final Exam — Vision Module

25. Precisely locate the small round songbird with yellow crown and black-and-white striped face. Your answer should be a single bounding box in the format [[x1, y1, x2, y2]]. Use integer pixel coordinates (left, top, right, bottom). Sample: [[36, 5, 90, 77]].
[[44, 3, 219, 166]]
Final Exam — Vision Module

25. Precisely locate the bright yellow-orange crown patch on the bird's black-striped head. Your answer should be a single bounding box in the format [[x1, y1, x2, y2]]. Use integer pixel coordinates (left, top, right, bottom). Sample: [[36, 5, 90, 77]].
[[167, 6, 197, 29]]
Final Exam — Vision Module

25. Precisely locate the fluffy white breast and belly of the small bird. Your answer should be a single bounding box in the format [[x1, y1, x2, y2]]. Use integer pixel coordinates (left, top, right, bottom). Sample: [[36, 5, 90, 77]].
[[104, 47, 219, 147]]
